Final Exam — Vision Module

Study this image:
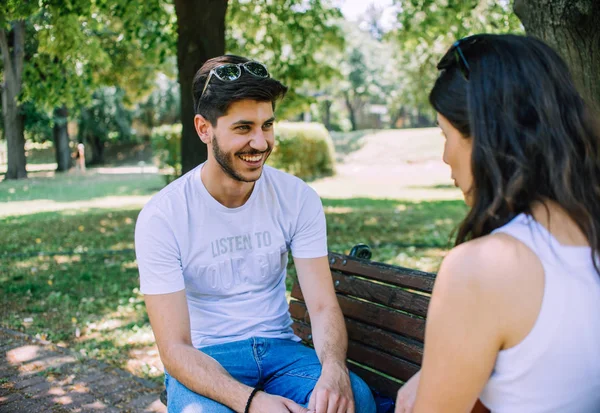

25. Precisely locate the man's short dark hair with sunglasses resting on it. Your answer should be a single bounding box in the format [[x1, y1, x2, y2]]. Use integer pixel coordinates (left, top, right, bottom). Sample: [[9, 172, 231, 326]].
[[192, 55, 287, 126]]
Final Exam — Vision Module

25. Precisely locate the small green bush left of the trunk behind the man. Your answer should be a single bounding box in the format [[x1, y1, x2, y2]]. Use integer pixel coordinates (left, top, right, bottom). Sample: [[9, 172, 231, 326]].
[[150, 123, 181, 183]]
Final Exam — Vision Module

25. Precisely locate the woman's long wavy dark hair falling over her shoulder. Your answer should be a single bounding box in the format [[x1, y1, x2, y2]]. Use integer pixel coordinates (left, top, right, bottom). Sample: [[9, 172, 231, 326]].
[[429, 34, 600, 273]]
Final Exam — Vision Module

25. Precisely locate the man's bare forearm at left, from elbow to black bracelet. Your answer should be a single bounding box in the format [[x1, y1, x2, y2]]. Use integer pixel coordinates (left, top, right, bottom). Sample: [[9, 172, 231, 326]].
[[162, 344, 252, 412]]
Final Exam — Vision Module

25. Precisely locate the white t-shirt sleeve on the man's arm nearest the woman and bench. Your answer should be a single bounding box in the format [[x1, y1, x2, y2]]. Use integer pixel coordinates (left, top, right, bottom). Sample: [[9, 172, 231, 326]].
[[290, 187, 327, 258]]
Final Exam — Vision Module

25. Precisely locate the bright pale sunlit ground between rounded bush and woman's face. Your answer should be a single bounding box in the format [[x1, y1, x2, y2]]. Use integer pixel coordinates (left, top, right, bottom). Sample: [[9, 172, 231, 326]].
[[310, 128, 462, 201]]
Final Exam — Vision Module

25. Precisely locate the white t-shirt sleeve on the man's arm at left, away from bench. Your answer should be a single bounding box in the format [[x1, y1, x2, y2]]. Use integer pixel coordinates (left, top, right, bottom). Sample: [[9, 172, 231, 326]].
[[135, 206, 185, 294]]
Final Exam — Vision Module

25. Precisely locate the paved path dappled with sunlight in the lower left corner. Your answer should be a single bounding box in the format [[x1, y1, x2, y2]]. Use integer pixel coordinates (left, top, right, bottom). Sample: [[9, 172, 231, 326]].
[[0, 328, 166, 413]]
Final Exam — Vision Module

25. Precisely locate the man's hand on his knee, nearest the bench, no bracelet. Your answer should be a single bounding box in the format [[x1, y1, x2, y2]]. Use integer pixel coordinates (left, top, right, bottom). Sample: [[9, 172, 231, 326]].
[[308, 363, 354, 413]]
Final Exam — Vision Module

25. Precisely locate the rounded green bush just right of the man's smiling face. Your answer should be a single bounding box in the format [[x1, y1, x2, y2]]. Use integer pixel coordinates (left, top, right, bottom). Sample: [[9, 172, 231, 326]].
[[269, 122, 335, 180]]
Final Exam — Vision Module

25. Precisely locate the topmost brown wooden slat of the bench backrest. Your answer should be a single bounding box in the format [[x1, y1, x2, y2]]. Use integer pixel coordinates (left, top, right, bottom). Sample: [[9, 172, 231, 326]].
[[329, 252, 435, 293]]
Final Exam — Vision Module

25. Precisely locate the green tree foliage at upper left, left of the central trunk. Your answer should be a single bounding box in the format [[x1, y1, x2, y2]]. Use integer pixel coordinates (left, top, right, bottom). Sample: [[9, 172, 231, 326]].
[[11, 0, 175, 113]]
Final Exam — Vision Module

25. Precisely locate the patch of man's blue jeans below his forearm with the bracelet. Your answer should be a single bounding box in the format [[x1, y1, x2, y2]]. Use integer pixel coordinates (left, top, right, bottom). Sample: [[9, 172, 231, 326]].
[[166, 376, 234, 413]]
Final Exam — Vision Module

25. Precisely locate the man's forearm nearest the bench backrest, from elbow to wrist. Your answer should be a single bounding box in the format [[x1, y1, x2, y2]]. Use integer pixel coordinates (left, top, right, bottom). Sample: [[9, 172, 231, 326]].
[[310, 306, 348, 367]]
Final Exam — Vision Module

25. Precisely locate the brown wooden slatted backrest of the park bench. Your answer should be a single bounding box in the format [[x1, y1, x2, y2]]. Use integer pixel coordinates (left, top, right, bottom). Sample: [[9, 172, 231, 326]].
[[290, 249, 435, 398]]
